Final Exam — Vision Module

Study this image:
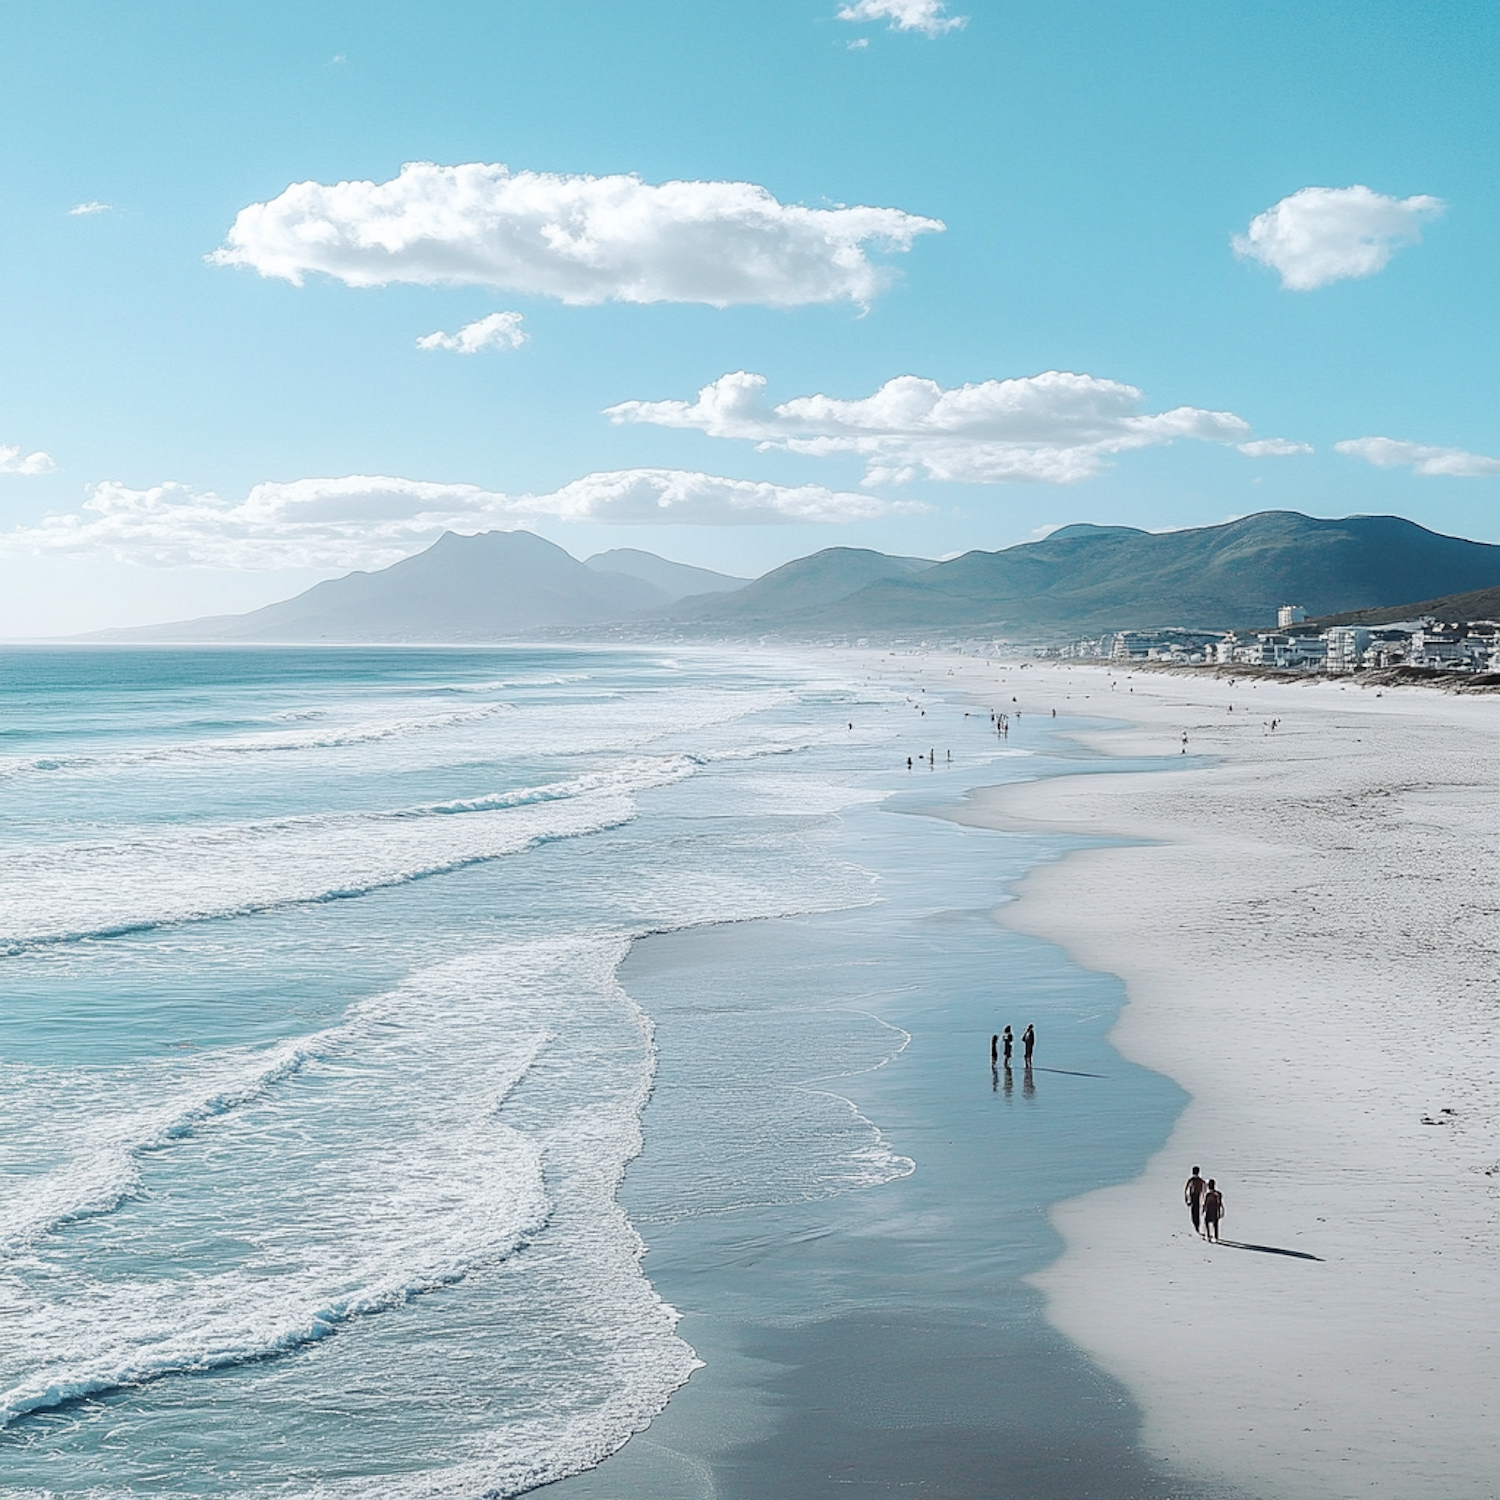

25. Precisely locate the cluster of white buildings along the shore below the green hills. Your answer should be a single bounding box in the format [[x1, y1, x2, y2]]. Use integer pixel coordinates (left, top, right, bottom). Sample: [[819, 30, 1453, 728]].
[[1034, 605, 1500, 674]]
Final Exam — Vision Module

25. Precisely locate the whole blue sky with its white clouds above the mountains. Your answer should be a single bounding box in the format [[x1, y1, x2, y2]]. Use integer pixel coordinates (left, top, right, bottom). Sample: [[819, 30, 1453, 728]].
[[0, 0, 1500, 639]]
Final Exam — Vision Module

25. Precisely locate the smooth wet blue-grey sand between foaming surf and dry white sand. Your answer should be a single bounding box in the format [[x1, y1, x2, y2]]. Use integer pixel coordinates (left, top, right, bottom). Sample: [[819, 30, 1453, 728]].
[[557, 756, 1238, 1500]]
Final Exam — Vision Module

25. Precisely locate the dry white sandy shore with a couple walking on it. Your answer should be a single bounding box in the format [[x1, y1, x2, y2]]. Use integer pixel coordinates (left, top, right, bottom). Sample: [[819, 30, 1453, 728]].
[[888, 656, 1500, 1500]]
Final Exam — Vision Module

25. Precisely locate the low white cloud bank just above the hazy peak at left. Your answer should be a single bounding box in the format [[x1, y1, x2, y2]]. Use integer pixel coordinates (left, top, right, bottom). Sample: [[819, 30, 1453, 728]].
[[0, 470, 927, 569]]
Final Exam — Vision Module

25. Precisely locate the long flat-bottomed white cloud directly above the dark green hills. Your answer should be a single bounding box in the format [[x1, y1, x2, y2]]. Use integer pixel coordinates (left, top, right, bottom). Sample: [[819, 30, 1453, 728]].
[[605, 371, 1250, 485]]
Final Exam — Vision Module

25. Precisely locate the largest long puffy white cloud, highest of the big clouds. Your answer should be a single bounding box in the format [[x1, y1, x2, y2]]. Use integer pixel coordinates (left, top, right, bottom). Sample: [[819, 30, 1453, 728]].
[[209, 162, 944, 308]]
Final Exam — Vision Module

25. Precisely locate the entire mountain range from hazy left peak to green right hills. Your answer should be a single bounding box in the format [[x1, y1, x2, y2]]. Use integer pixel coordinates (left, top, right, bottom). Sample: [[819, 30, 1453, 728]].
[[76, 512, 1500, 642]]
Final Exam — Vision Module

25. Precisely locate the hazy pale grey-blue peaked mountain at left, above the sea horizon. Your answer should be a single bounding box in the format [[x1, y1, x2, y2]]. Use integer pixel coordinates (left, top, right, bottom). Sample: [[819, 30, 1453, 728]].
[[80, 531, 672, 642]]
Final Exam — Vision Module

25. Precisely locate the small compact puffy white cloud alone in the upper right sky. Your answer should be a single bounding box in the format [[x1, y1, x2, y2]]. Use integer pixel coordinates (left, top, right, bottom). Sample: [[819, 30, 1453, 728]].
[[1232, 185, 1446, 291]]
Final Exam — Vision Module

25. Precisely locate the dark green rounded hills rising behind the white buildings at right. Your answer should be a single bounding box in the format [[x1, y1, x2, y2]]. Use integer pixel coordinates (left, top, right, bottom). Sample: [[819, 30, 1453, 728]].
[[672, 512, 1500, 639]]
